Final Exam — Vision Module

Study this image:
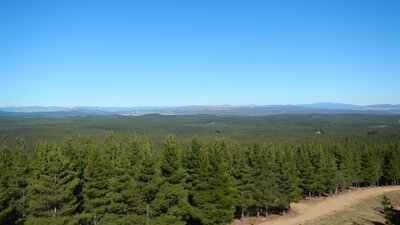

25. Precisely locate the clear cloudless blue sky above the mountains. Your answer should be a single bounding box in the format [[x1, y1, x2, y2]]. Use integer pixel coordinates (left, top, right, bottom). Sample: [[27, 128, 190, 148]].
[[0, 0, 400, 106]]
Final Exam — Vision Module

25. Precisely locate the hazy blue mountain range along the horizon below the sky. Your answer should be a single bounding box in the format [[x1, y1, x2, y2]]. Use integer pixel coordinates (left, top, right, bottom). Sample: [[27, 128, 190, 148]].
[[0, 102, 400, 117]]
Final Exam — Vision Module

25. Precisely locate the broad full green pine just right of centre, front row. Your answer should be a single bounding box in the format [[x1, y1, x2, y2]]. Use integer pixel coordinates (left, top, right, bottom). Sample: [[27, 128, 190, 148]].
[[192, 140, 236, 225]]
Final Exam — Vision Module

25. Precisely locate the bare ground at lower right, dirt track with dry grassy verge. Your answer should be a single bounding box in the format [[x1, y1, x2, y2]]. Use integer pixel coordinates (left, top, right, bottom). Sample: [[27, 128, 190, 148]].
[[231, 186, 400, 225]]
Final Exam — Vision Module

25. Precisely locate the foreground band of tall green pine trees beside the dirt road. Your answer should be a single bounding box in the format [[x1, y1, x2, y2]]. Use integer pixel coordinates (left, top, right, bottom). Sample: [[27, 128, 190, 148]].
[[0, 134, 400, 225]]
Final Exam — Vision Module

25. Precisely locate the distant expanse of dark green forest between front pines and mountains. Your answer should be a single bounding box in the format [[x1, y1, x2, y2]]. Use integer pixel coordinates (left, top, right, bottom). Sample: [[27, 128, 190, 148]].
[[0, 114, 400, 149]]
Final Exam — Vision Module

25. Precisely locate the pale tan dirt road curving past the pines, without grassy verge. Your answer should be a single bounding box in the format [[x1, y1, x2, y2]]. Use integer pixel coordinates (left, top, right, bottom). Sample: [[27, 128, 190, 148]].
[[260, 186, 400, 225]]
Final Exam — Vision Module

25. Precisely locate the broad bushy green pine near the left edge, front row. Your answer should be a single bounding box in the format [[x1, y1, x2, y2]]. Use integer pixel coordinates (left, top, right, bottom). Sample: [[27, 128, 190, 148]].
[[26, 143, 79, 224]]
